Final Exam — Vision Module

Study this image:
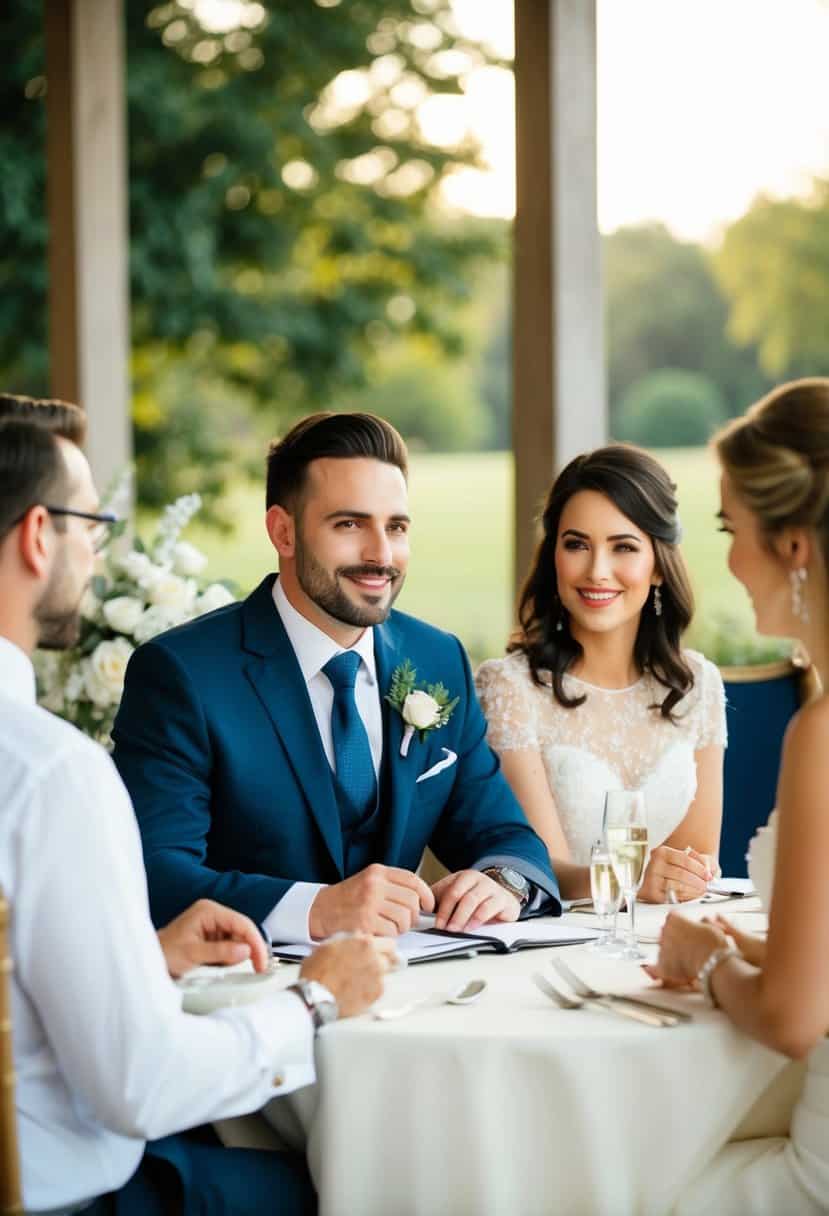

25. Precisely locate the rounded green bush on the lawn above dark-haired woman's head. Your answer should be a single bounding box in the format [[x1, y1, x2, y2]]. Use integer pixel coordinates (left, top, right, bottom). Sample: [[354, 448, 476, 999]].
[[614, 367, 727, 447]]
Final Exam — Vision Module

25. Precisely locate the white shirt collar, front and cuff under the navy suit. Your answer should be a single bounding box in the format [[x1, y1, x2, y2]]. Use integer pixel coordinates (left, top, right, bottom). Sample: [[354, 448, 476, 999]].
[[264, 579, 383, 941]]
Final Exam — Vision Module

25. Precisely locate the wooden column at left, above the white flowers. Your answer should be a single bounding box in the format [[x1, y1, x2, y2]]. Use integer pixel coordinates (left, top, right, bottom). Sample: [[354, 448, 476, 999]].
[[44, 0, 131, 489]]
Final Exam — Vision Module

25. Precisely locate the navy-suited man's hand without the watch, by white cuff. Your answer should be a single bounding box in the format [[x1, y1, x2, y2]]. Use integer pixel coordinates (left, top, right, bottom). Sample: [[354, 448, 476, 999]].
[[308, 862, 435, 940]]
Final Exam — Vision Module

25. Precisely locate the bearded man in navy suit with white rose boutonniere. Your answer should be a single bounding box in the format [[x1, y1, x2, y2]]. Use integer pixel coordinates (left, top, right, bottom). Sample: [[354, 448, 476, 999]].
[[113, 413, 560, 941]]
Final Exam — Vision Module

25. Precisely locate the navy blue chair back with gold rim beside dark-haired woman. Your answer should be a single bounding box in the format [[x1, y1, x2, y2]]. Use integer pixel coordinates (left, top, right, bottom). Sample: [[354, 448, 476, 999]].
[[720, 659, 817, 878]]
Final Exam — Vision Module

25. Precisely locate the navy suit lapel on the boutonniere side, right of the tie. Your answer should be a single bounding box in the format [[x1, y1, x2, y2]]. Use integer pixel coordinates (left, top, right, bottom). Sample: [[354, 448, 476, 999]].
[[374, 621, 423, 866]]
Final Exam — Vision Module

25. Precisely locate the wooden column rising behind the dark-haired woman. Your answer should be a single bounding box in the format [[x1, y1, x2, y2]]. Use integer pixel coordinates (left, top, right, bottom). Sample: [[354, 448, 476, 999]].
[[513, 0, 607, 598]]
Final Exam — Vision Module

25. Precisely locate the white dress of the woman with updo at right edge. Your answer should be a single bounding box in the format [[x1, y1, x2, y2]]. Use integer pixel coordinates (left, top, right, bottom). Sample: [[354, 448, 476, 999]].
[[675, 811, 829, 1216]]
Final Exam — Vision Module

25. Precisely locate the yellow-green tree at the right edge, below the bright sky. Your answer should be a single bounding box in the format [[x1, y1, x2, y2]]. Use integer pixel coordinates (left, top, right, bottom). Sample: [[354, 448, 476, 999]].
[[714, 179, 829, 378]]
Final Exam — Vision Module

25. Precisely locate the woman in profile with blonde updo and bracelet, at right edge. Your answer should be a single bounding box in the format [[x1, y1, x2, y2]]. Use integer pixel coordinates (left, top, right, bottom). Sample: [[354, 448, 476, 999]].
[[652, 379, 829, 1216]]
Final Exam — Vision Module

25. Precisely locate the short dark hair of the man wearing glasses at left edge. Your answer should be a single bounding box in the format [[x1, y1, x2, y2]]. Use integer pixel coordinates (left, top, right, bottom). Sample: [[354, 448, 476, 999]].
[[0, 418, 68, 544]]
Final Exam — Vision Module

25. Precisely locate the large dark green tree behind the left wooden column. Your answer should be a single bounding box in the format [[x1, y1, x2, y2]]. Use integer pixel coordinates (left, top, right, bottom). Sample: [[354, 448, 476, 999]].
[[0, 0, 494, 503]]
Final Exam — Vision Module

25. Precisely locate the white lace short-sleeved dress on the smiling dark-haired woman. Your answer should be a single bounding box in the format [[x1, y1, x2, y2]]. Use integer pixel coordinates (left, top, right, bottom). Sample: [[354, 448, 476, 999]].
[[475, 651, 726, 865]]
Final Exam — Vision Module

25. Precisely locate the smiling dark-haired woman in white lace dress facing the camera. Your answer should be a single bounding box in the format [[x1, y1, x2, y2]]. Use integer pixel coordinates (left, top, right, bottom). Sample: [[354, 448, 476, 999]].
[[475, 444, 726, 902]]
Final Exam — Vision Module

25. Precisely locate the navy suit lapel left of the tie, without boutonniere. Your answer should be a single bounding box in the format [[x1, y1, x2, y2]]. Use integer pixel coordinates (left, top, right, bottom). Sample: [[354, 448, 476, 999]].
[[242, 575, 345, 876]]
